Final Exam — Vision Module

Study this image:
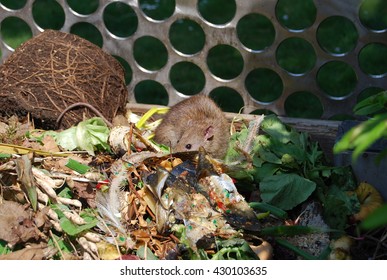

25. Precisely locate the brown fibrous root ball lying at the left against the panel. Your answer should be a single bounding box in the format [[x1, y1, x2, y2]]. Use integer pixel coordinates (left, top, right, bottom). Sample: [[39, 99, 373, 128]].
[[0, 30, 128, 129]]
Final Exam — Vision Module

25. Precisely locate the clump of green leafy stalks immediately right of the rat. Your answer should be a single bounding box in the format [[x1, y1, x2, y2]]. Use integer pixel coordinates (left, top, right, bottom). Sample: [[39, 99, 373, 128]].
[[225, 115, 359, 230]]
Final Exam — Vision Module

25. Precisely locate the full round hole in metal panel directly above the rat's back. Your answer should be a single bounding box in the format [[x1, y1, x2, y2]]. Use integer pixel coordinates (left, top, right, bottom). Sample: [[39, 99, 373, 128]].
[[169, 61, 206, 95]]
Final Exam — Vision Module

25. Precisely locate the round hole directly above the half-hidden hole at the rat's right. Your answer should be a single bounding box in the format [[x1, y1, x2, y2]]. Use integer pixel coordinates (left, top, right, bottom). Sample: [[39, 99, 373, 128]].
[[207, 45, 244, 80]]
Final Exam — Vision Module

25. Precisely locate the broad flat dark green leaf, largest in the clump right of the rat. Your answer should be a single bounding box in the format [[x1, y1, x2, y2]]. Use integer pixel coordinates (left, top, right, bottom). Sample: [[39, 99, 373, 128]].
[[260, 174, 316, 210]]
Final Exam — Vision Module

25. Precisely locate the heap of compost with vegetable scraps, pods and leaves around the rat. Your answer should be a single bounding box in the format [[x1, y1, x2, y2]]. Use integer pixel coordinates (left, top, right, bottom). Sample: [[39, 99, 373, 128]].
[[0, 31, 387, 260]]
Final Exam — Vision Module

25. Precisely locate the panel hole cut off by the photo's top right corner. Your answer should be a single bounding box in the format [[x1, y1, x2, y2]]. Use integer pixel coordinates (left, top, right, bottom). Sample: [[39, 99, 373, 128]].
[[359, 0, 387, 31]]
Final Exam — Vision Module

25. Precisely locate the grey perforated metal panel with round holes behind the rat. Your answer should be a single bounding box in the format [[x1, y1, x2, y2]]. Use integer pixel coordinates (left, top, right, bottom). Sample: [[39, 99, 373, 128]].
[[0, 0, 387, 119]]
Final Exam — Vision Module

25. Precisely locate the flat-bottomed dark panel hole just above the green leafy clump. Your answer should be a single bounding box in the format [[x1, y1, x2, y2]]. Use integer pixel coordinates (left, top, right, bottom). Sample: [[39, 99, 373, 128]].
[[284, 91, 324, 119]]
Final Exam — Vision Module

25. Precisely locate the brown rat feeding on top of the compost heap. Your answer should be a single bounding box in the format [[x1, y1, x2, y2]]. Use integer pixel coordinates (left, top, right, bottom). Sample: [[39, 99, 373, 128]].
[[155, 95, 230, 158]]
